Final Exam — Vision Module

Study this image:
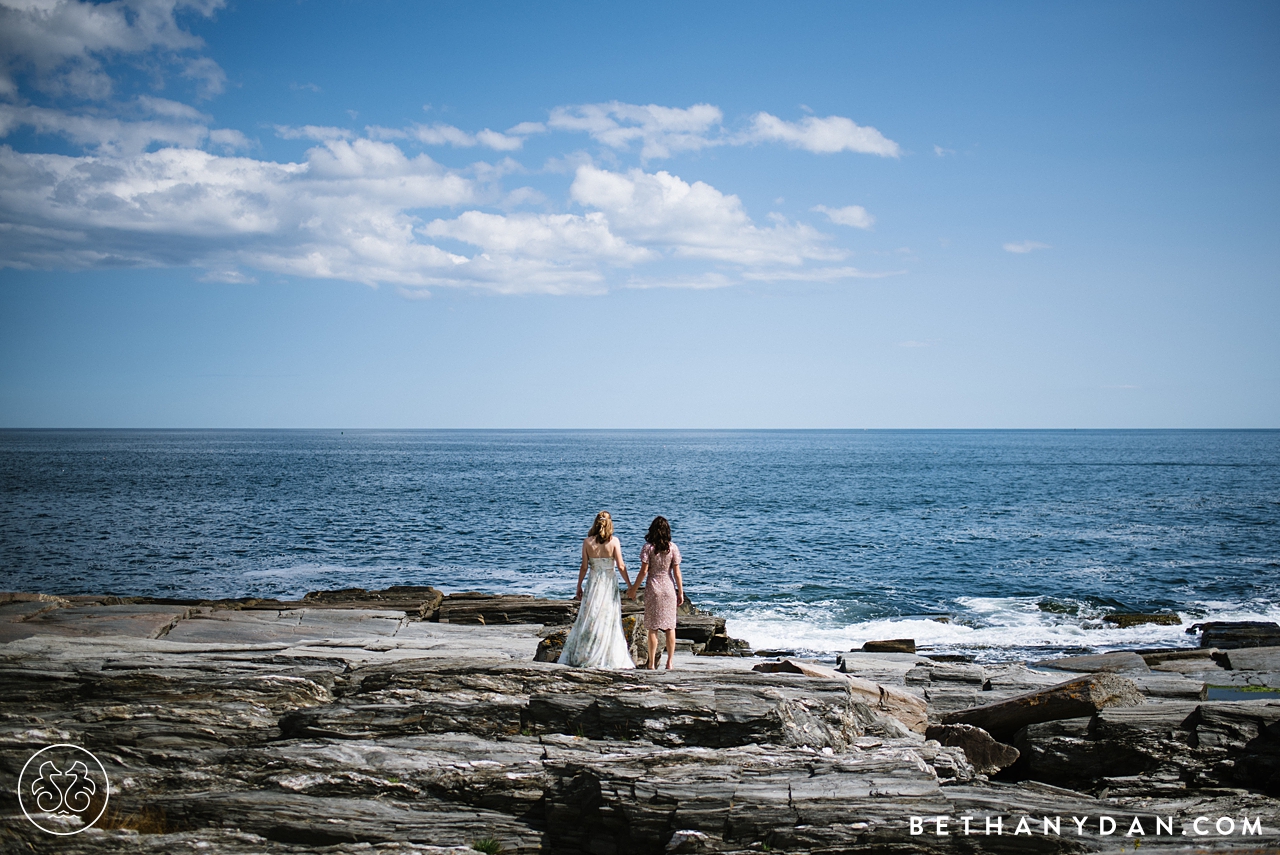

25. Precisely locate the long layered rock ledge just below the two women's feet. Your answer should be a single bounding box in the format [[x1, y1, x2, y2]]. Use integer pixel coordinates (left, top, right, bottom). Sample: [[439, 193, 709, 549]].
[[280, 660, 890, 750]]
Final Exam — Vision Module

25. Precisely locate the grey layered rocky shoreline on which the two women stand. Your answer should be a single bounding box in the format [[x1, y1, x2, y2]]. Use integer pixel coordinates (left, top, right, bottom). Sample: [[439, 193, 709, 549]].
[[0, 587, 1280, 855]]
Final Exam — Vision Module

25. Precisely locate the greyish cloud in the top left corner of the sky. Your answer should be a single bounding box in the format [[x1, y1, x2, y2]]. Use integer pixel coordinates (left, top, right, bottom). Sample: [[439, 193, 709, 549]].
[[0, 0, 225, 100]]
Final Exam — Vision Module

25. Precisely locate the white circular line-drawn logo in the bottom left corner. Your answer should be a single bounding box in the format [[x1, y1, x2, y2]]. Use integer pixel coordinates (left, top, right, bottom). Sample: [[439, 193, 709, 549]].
[[18, 742, 111, 835]]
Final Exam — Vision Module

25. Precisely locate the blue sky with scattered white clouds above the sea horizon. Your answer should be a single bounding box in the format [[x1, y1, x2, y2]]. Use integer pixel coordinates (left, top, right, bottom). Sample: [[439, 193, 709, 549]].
[[0, 0, 1280, 428]]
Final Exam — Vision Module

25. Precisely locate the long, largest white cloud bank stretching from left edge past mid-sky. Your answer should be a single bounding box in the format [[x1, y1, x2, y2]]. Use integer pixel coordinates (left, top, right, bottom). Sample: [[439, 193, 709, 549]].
[[0, 136, 892, 290]]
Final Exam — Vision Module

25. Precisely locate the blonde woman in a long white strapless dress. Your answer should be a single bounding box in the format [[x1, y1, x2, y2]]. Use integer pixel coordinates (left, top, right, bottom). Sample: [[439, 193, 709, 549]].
[[559, 511, 635, 668]]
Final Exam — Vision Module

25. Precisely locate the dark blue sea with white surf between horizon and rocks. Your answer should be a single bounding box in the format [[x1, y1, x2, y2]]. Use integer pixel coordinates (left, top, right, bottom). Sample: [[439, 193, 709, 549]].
[[0, 430, 1280, 659]]
